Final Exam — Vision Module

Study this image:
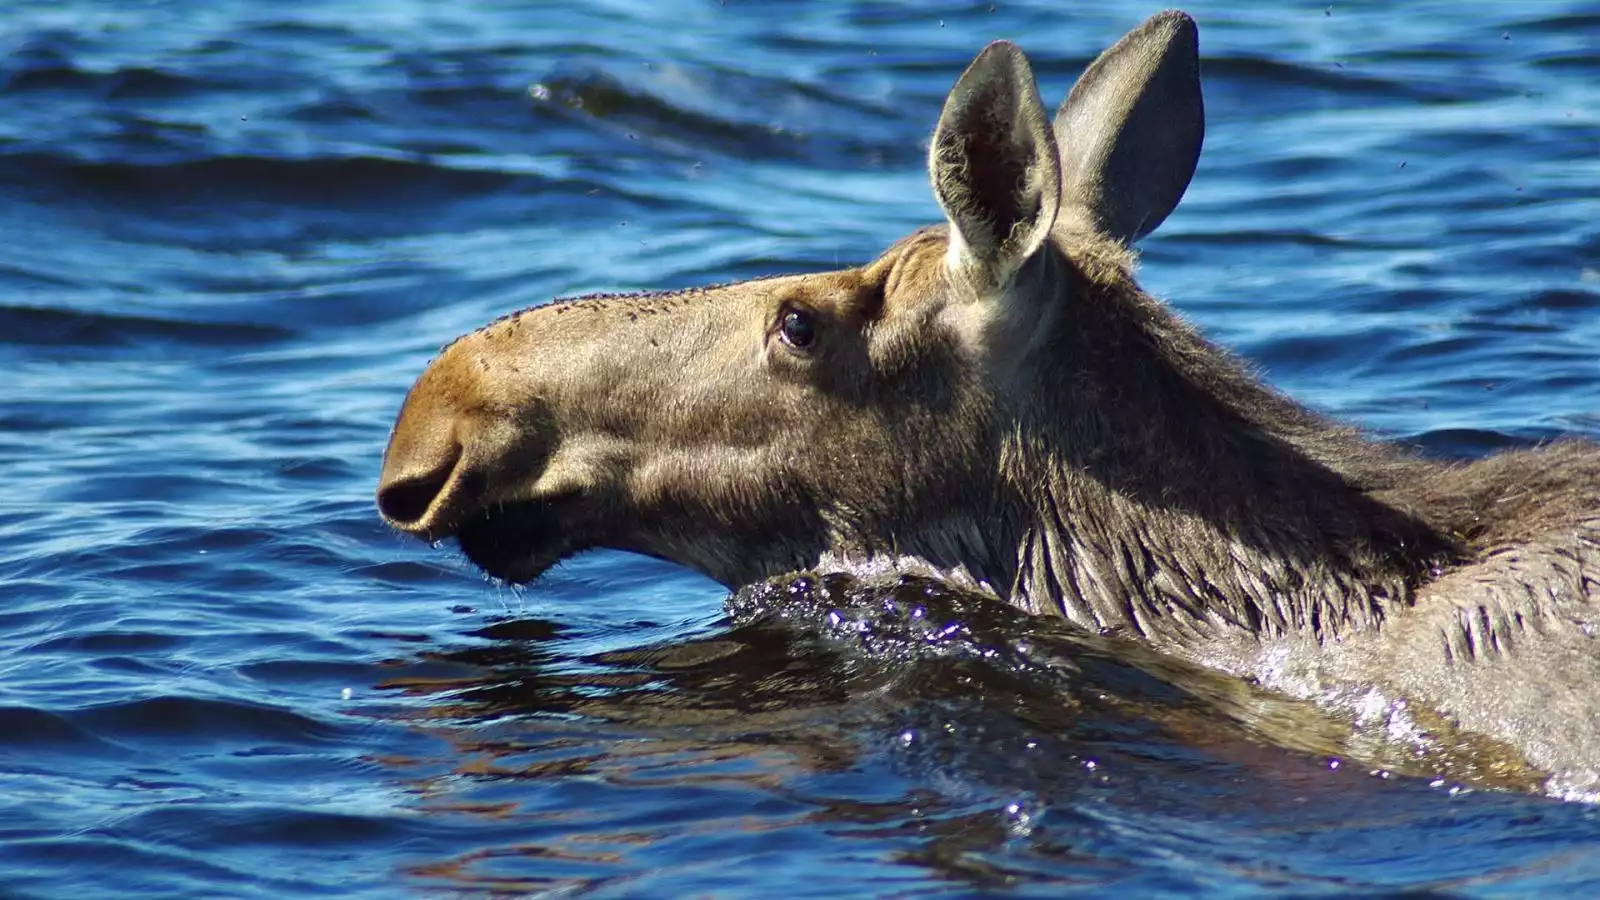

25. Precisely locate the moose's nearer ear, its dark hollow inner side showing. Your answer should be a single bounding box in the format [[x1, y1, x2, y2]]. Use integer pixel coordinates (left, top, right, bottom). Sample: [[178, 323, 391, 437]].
[[928, 40, 1061, 287]]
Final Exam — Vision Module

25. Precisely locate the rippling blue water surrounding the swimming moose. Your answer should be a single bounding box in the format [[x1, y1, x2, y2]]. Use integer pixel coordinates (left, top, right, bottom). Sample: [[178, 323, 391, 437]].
[[0, 0, 1600, 900]]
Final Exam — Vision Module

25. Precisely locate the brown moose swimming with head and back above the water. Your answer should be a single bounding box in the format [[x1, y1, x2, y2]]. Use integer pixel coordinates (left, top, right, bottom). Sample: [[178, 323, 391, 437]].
[[378, 10, 1600, 790]]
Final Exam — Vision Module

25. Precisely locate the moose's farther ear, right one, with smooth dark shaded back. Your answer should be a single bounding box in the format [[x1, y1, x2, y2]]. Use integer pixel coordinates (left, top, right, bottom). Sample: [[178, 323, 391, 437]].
[[1056, 10, 1205, 245]]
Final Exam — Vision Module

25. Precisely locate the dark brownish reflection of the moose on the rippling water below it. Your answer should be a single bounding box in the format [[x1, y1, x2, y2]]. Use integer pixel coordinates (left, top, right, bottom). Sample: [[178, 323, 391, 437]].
[[368, 575, 1531, 892]]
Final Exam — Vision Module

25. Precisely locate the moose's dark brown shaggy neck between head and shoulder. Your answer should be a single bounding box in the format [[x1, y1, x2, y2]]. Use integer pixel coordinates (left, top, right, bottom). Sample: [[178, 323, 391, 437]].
[[1002, 241, 1454, 642]]
